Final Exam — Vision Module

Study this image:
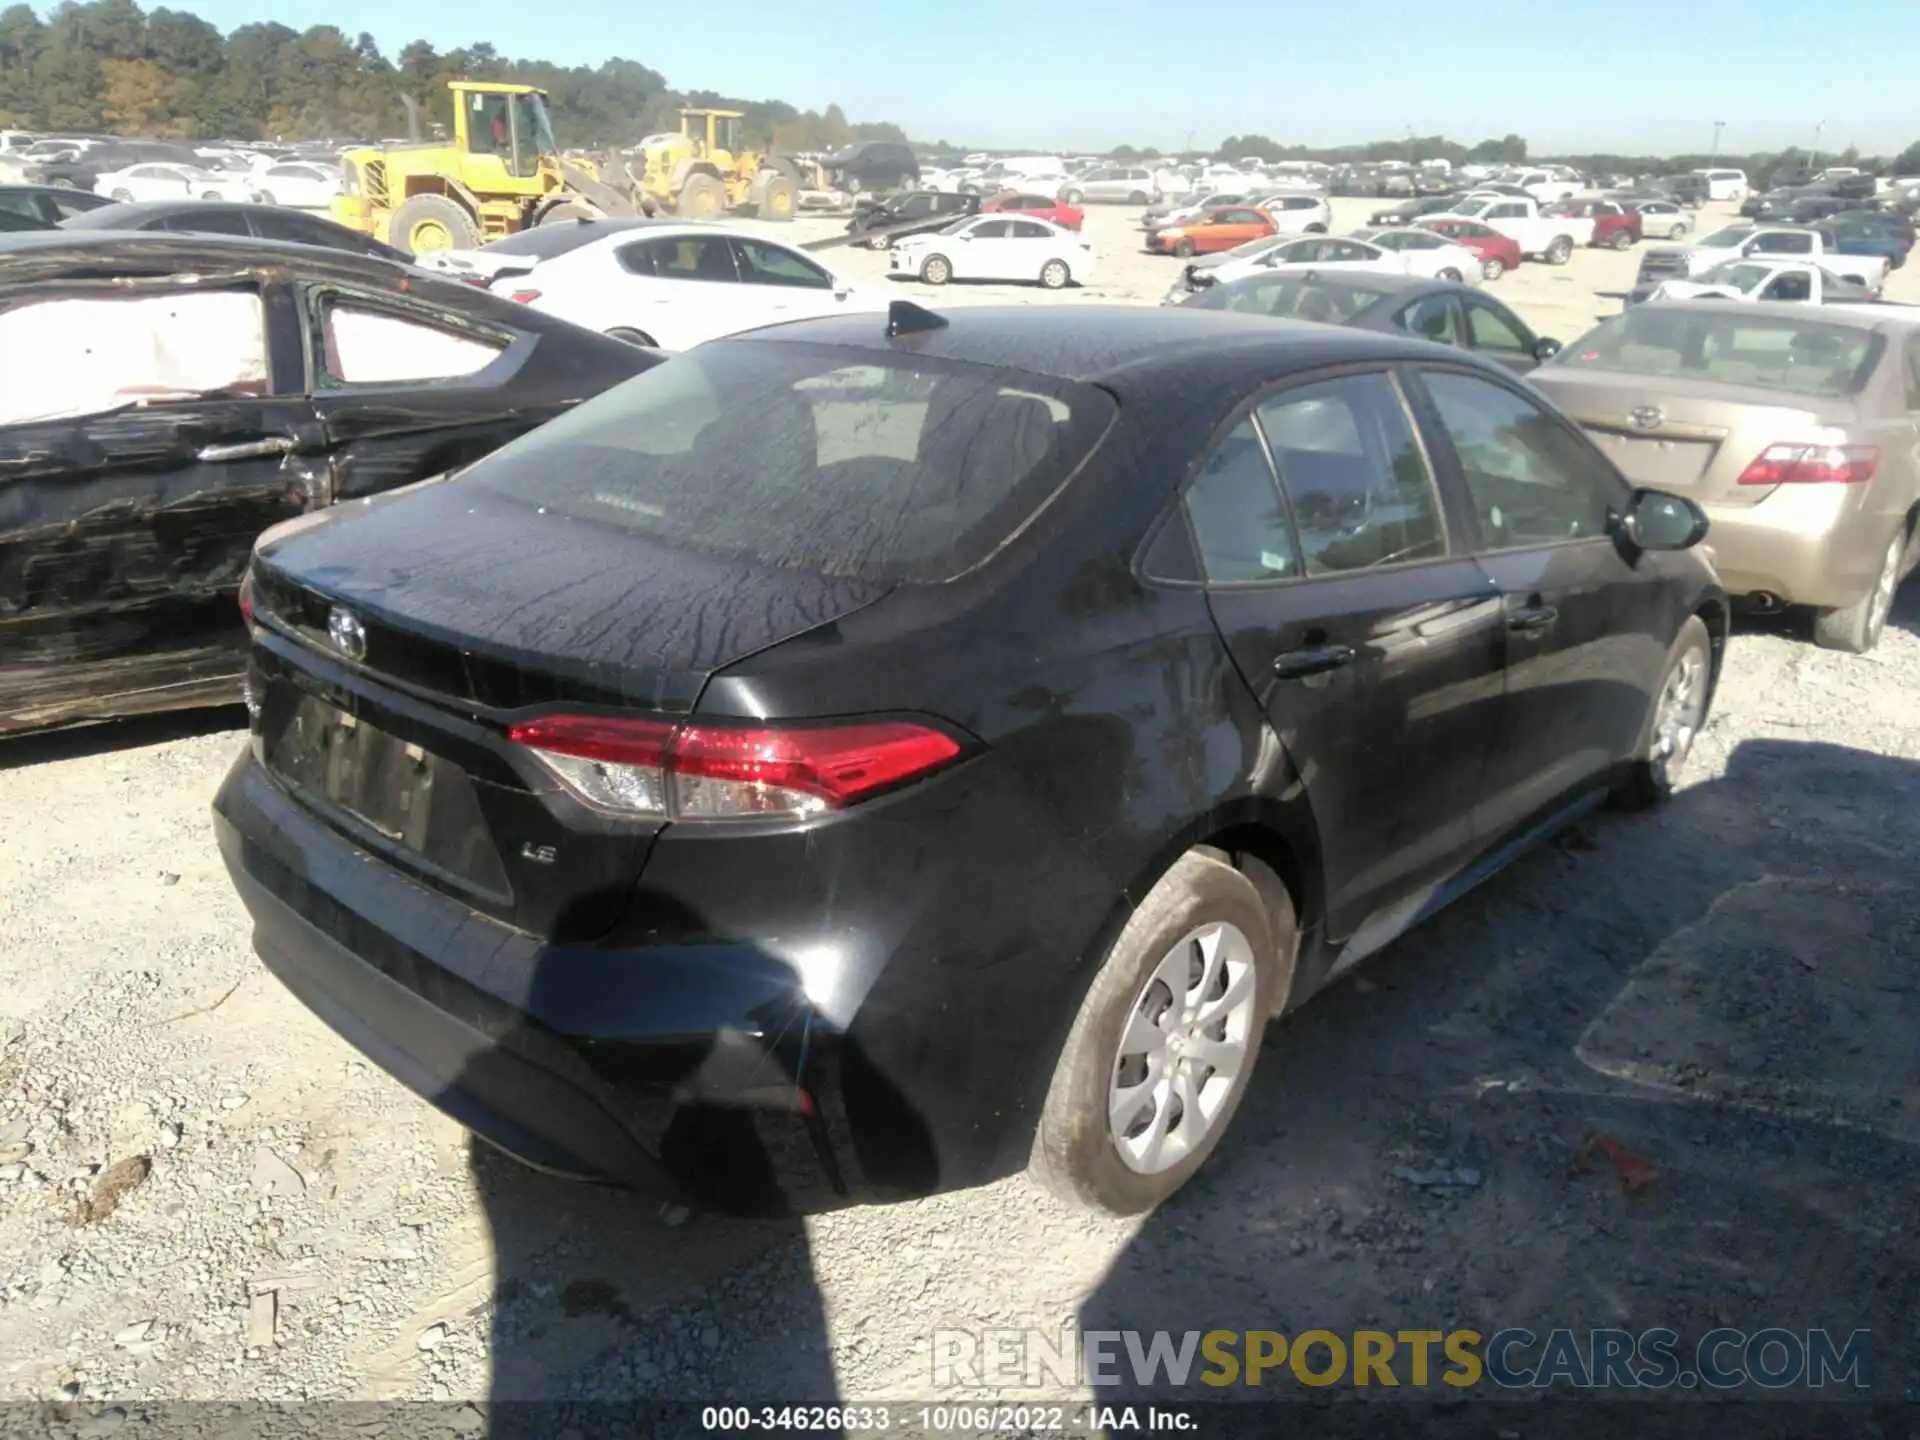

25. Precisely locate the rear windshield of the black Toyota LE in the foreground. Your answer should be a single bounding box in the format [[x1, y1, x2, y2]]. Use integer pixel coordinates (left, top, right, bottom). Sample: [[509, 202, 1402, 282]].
[[457, 340, 1117, 584]]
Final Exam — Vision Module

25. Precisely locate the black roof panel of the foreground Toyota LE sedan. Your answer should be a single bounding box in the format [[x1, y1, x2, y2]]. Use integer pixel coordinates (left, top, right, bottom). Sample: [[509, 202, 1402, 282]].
[[714, 301, 1452, 382]]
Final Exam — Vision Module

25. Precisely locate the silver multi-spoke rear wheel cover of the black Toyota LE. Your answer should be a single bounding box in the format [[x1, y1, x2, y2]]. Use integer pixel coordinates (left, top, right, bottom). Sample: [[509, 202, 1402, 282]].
[[1106, 922, 1258, 1175]]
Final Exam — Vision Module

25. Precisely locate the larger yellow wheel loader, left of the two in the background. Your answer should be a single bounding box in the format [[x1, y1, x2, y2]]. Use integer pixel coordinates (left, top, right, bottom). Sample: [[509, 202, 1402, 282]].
[[332, 81, 648, 255]]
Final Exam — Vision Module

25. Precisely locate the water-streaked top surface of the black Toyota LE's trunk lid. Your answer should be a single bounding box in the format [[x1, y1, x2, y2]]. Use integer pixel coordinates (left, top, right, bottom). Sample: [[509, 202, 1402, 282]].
[[255, 480, 891, 712]]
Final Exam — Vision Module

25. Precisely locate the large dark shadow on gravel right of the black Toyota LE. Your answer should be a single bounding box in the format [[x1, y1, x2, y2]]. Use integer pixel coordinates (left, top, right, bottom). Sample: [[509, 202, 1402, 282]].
[[1079, 744, 1920, 1434]]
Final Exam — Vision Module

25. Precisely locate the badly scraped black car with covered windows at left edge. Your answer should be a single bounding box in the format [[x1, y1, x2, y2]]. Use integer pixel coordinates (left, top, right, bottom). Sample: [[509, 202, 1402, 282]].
[[0, 230, 659, 733]]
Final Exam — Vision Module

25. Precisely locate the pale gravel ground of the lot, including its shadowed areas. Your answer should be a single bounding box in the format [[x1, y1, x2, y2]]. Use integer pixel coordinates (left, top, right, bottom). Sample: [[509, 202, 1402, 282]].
[[0, 194, 1920, 1402]]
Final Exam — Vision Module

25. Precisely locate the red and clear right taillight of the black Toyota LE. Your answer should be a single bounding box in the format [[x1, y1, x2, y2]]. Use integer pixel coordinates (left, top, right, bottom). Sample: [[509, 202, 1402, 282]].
[[507, 714, 960, 820]]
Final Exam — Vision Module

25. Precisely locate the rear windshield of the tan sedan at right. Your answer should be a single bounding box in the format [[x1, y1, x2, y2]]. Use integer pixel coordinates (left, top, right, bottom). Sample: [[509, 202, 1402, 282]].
[[1549, 305, 1880, 396]]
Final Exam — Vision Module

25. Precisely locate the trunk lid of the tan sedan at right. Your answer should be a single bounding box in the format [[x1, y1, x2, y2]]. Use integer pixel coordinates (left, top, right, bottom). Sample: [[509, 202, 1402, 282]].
[[1534, 367, 1853, 507]]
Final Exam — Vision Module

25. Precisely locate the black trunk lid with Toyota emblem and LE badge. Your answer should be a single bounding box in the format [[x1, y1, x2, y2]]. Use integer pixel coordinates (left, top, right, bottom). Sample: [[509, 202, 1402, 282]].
[[250, 480, 887, 941]]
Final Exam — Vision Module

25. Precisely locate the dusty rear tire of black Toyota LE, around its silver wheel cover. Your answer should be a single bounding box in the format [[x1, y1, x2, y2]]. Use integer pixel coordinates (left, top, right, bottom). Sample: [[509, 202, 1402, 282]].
[[1027, 851, 1294, 1215]]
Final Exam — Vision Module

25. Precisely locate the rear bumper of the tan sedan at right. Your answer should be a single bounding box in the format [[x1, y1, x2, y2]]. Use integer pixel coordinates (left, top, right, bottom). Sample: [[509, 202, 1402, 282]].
[[1707, 486, 1899, 609]]
